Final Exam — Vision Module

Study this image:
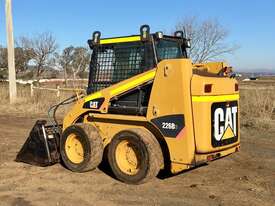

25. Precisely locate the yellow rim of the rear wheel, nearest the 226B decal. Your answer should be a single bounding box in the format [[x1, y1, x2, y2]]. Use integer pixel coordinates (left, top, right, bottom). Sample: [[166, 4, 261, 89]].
[[115, 140, 140, 175]]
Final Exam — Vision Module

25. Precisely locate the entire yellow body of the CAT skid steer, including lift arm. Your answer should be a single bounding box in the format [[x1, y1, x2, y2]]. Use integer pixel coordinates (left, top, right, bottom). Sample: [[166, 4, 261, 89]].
[[63, 58, 240, 173]]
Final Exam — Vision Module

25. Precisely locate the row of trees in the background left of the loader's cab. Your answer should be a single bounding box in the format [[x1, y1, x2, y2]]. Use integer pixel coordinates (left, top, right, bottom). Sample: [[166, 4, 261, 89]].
[[0, 32, 89, 78]]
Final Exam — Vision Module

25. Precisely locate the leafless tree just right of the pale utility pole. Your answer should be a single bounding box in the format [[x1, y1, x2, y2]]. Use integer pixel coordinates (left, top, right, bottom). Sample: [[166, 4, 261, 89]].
[[30, 32, 58, 77]]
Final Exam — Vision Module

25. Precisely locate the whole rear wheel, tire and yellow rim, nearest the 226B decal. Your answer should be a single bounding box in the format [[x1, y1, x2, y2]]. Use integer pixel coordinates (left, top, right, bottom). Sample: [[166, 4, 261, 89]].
[[108, 129, 163, 184]]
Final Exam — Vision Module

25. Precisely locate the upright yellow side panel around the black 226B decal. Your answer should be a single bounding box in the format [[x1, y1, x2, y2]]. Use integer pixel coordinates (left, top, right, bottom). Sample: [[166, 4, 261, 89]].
[[147, 59, 195, 166]]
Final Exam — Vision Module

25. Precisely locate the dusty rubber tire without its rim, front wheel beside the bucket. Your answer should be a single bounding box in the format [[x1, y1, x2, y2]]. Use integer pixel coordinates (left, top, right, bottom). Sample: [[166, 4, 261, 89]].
[[60, 123, 103, 172]]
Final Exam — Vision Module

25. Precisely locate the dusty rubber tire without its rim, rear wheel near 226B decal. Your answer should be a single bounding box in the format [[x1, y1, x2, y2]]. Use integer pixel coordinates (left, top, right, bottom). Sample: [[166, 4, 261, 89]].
[[108, 129, 163, 184]]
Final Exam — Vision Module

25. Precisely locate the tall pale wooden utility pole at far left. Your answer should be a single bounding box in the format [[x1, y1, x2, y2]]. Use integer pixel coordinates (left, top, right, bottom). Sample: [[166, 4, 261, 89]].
[[6, 0, 17, 104]]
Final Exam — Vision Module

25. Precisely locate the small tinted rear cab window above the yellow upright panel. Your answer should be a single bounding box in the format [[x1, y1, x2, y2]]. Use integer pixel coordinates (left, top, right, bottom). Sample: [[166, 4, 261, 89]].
[[156, 39, 183, 61]]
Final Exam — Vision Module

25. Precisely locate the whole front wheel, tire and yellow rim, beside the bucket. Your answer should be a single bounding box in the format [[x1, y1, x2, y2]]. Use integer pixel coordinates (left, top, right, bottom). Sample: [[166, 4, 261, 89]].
[[60, 123, 103, 172]]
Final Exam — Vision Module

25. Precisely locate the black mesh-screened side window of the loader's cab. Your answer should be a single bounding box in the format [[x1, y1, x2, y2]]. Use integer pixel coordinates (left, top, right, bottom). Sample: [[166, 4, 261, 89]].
[[87, 42, 155, 94]]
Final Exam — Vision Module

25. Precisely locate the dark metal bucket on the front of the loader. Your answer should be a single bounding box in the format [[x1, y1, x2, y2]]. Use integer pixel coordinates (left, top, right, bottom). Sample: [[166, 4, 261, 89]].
[[15, 120, 60, 167]]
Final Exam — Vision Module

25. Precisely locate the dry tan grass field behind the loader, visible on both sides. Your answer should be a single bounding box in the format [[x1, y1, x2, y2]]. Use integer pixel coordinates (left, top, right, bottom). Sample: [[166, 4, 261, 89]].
[[0, 81, 275, 121]]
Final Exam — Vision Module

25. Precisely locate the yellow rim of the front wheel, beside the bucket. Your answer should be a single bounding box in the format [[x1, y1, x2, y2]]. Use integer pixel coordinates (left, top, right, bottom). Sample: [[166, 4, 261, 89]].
[[65, 134, 84, 164]]
